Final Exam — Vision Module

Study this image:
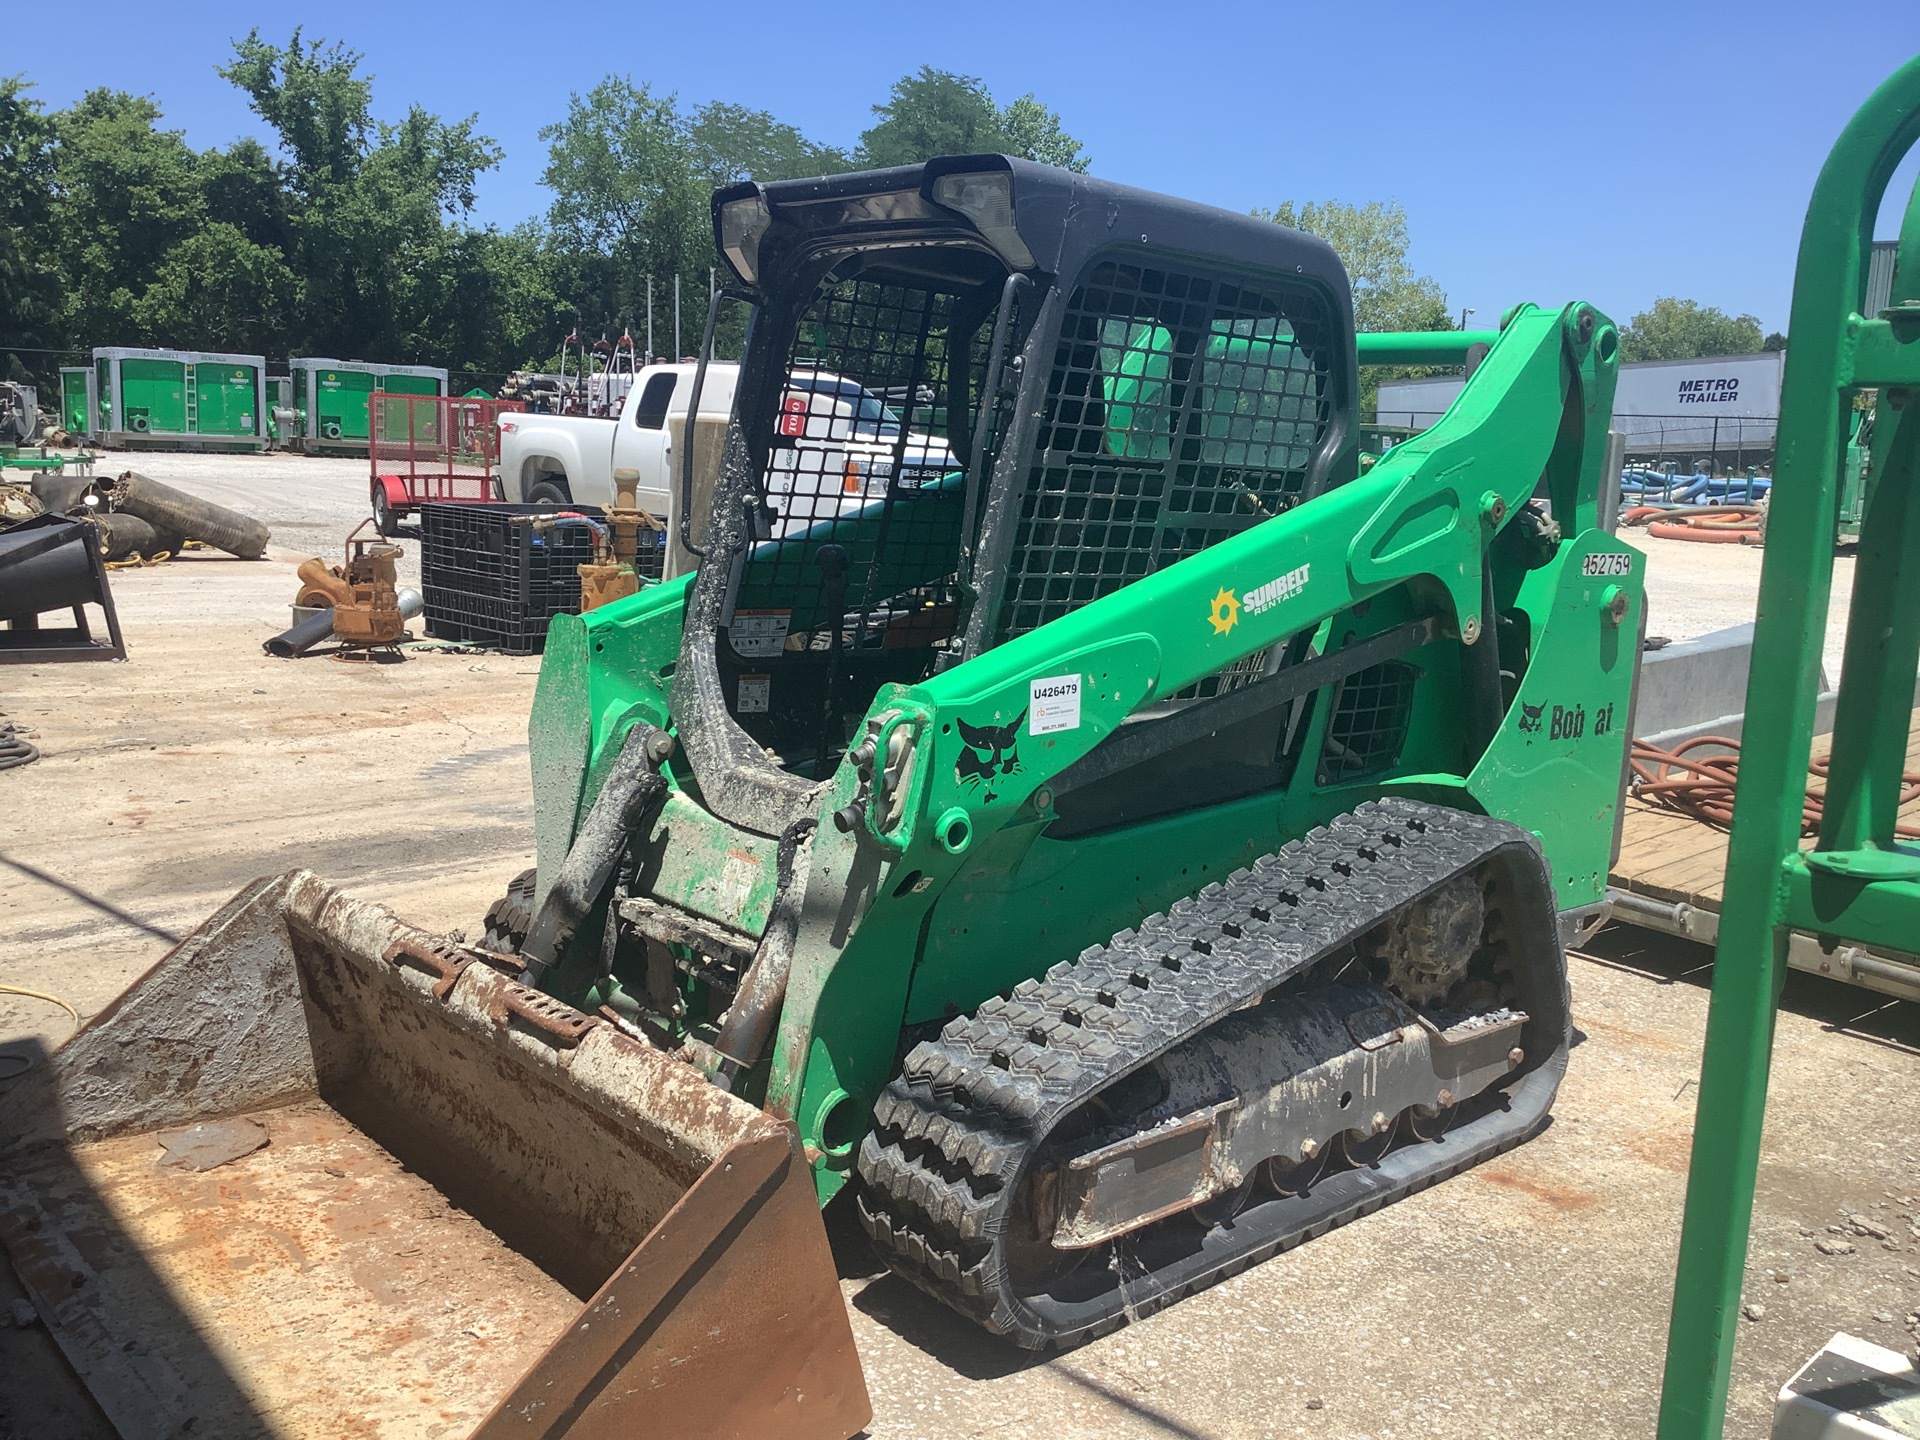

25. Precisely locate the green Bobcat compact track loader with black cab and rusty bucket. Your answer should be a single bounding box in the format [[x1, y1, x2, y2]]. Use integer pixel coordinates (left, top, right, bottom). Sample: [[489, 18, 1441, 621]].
[[10, 156, 1644, 1434]]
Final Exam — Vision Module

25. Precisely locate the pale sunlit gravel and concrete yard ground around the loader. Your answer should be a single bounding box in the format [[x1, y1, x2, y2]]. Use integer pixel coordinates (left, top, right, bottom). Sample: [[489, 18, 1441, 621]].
[[0, 455, 1920, 1440]]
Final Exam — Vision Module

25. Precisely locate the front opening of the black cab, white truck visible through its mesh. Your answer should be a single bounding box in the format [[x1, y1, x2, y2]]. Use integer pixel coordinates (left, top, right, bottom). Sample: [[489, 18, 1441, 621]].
[[720, 264, 1000, 774]]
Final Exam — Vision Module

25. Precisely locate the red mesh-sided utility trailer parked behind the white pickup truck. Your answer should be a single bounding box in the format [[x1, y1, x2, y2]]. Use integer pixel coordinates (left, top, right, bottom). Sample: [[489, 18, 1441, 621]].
[[367, 390, 526, 536]]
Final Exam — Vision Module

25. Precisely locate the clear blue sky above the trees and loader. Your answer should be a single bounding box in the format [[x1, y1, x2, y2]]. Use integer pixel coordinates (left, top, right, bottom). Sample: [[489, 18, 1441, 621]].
[[15, 0, 1920, 328]]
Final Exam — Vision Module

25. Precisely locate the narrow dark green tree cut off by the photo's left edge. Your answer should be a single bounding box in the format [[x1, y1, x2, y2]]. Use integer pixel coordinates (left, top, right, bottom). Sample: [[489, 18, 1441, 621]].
[[0, 77, 60, 382]]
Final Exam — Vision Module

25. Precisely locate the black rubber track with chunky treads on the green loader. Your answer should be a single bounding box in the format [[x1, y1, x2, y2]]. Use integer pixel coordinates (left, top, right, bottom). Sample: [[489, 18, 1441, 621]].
[[858, 799, 1532, 1348]]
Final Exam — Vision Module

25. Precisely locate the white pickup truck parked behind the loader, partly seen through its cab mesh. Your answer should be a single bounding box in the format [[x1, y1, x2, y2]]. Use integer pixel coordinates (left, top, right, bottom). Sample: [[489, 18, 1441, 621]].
[[499, 361, 954, 534]]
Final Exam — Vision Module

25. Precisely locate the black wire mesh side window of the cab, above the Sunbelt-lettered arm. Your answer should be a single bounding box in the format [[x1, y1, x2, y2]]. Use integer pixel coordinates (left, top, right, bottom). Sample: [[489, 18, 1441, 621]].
[[996, 259, 1332, 645]]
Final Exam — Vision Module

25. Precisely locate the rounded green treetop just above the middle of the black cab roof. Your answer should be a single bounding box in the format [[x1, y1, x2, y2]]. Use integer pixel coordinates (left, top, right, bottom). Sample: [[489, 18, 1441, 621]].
[[858, 65, 1089, 171]]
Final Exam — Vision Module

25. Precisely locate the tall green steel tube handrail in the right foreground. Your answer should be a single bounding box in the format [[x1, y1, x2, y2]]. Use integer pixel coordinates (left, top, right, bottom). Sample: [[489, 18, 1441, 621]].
[[1659, 60, 1920, 1440]]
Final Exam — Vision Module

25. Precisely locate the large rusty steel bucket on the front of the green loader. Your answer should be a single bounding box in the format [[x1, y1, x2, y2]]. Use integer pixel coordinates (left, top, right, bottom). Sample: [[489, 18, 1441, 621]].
[[0, 872, 872, 1440]]
